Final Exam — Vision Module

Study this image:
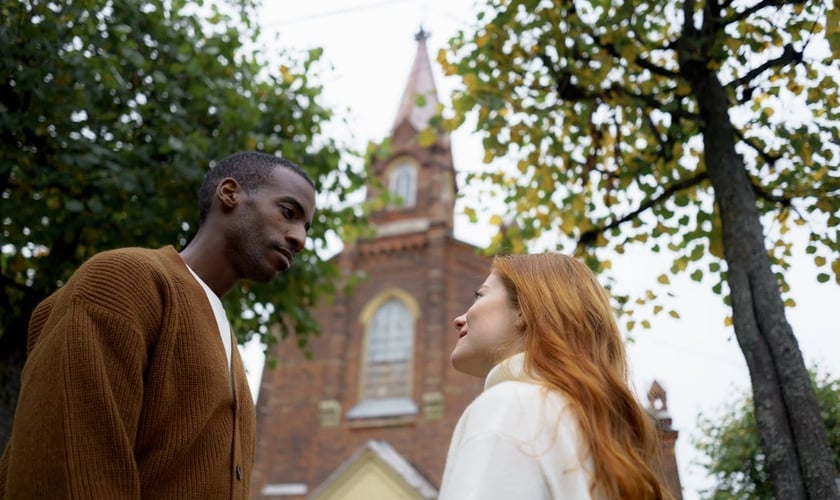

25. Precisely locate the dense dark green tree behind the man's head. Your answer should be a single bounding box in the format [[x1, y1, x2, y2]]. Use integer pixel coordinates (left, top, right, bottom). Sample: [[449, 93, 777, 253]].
[[0, 0, 364, 445]]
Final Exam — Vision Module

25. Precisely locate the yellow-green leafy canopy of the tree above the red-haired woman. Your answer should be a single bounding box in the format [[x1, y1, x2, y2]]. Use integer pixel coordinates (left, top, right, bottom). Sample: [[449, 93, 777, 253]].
[[438, 0, 840, 329]]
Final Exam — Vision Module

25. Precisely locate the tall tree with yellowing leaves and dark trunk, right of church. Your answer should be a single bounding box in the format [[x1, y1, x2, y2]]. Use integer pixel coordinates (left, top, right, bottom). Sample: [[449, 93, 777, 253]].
[[439, 0, 840, 499]]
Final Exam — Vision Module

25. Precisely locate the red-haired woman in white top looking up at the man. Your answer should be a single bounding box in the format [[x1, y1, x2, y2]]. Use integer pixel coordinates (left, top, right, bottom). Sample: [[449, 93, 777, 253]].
[[439, 254, 666, 500]]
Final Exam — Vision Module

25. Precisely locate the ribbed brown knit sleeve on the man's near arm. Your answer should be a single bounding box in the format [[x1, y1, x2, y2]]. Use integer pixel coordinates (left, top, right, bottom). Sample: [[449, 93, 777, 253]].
[[1, 252, 160, 499]]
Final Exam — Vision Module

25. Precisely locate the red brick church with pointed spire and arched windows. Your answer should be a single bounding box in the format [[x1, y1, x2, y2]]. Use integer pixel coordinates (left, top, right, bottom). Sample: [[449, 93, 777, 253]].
[[251, 29, 681, 500]]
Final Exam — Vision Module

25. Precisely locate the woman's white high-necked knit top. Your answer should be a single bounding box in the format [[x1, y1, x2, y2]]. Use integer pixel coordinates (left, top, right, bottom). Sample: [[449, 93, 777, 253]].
[[438, 353, 593, 500]]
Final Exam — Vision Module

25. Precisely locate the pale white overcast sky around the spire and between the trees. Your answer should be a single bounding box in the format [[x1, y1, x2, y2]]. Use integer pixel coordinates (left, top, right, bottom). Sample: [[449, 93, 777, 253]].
[[240, 0, 840, 500]]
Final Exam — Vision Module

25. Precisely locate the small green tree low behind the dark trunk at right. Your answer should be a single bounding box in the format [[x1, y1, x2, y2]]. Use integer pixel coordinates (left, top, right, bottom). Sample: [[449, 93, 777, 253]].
[[695, 371, 840, 500]]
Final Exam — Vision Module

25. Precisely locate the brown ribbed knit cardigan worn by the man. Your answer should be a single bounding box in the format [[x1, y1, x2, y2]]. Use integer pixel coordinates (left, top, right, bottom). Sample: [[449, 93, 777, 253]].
[[0, 246, 255, 500]]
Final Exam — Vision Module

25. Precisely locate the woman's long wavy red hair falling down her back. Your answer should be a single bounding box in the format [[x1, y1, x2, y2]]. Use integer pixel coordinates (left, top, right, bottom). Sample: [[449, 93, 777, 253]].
[[492, 253, 669, 499]]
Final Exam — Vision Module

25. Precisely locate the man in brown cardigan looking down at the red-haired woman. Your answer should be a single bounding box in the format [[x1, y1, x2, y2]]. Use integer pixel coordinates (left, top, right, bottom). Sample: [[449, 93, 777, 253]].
[[0, 152, 315, 500]]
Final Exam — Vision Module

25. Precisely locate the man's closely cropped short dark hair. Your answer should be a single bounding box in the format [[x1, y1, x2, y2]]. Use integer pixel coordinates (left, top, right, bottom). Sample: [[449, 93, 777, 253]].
[[198, 151, 315, 226]]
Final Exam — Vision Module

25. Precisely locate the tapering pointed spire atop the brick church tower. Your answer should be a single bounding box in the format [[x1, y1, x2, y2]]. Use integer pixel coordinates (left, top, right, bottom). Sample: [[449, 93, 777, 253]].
[[391, 26, 440, 132]]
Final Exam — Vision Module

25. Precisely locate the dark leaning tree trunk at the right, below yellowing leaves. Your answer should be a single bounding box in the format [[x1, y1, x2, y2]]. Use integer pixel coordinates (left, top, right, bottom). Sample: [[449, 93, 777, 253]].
[[683, 60, 840, 500]]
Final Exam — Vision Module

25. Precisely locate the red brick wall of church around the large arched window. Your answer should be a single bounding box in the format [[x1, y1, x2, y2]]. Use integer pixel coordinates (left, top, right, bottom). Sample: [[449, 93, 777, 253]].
[[252, 236, 489, 498]]
